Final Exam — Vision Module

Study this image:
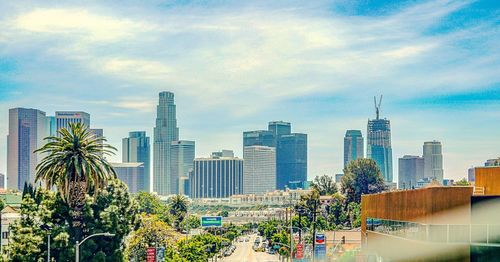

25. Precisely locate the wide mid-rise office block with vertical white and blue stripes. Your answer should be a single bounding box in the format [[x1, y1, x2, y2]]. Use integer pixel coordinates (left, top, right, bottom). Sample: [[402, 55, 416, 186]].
[[189, 151, 243, 198]]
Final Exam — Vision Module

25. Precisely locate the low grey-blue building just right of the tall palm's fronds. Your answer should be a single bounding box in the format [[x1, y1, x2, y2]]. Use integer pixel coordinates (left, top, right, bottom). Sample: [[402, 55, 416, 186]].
[[111, 162, 149, 193]]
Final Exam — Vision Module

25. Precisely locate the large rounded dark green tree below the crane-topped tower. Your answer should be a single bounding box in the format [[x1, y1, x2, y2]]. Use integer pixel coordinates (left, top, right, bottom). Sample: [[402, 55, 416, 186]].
[[341, 158, 385, 203]]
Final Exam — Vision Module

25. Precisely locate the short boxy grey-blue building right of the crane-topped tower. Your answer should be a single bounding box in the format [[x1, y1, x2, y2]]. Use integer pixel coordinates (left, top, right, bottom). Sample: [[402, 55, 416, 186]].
[[398, 155, 424, 189]]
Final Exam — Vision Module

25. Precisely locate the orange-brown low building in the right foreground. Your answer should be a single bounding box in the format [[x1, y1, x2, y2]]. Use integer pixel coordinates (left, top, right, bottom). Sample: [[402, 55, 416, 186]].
[[361, 167, 500, 261]]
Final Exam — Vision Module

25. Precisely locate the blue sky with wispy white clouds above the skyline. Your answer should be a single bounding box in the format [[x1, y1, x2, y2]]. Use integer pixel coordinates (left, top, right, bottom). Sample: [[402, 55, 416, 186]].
[[0, 0, 500, 179]]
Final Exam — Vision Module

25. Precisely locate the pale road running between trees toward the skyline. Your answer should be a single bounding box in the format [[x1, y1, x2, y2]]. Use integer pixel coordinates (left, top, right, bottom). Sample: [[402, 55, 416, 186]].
[[222, 235, 279, 262]]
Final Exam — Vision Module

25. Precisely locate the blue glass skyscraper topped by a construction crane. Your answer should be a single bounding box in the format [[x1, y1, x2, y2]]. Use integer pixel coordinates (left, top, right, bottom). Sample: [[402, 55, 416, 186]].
[[366, 97, 393, 182]]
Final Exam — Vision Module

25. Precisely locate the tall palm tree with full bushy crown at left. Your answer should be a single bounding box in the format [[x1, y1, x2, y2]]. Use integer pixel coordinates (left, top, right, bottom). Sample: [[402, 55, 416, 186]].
[[35, 123, 116, 238]]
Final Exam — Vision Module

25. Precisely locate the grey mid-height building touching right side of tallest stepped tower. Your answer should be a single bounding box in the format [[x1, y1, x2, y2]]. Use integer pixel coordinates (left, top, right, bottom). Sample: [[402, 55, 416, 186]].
[[170, 140, 195, 194]]
